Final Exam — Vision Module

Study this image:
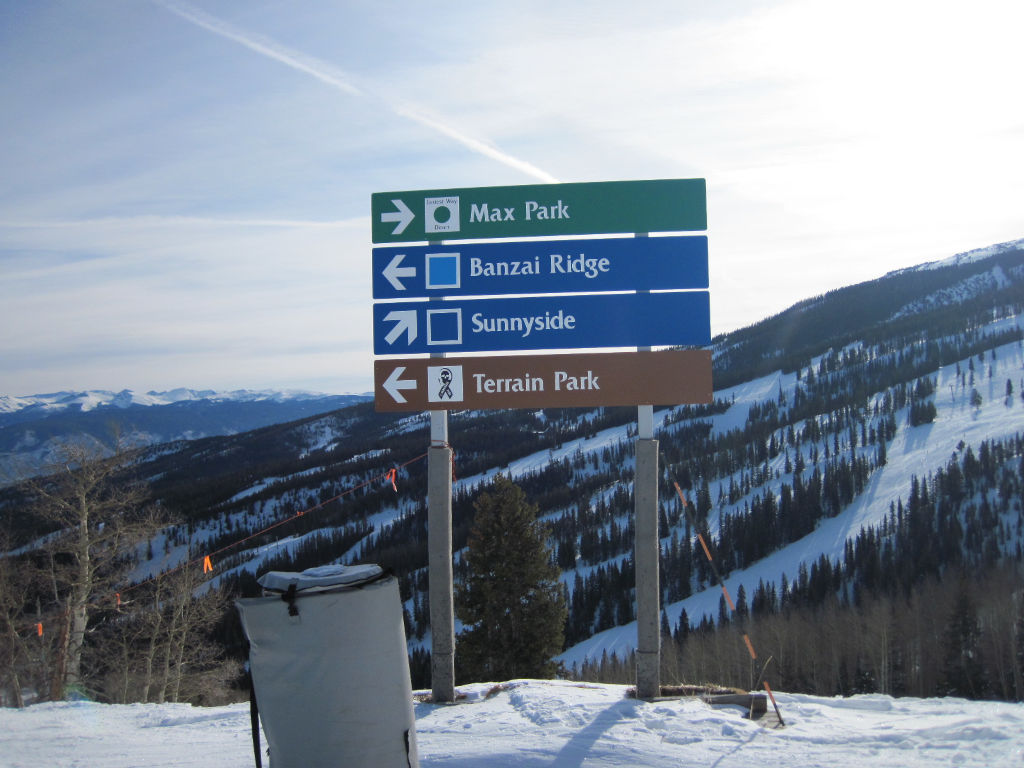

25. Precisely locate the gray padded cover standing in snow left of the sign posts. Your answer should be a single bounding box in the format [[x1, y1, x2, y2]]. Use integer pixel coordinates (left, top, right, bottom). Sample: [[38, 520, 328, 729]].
[[237, 566, 419, 768]]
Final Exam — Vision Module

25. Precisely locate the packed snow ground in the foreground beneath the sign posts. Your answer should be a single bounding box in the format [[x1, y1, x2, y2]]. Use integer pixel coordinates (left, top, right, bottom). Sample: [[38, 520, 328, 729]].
[[0, 681, 1024, 768]]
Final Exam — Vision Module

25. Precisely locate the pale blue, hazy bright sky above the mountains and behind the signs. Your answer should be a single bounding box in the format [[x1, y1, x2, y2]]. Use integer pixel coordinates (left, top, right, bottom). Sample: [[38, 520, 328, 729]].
[[0, 0, 1024, 395]]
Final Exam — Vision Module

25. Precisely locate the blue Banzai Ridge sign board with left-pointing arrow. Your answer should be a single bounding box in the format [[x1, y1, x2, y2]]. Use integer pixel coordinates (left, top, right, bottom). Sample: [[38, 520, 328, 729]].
[[373, 234, 708, 299]]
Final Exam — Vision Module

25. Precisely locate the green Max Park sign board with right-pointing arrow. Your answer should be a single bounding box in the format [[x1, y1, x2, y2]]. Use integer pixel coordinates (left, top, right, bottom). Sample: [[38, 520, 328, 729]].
[[371, 178, 708, 243]]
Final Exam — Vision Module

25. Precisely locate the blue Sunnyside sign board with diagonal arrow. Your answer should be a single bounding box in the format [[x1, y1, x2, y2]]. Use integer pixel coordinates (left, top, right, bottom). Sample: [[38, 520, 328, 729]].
[[374, 291, 711, 354]]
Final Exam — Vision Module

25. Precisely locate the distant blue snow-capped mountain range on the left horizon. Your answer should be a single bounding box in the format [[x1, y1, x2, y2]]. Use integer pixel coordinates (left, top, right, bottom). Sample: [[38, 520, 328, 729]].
[[0, 388, 372, 484]]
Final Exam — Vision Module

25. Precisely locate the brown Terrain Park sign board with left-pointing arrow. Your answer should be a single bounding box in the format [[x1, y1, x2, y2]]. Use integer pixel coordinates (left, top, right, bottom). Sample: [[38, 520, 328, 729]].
[[374, 349, 713, 411]]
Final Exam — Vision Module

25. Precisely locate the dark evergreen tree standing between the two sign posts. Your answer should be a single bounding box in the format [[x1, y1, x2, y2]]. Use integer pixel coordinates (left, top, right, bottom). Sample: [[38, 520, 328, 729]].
[[456, 475, 566, 681]]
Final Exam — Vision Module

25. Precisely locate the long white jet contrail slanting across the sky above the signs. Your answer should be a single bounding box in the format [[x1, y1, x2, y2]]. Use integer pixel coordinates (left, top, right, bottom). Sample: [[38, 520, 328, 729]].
[[154, 0, 558, 183]]
